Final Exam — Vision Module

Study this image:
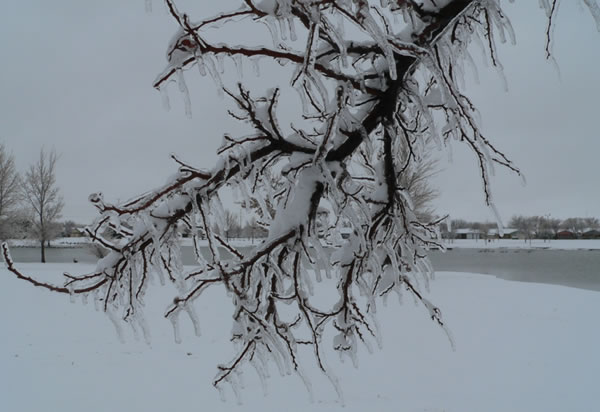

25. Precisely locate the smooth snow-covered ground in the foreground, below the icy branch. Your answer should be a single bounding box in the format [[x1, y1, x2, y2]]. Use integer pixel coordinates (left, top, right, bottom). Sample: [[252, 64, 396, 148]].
[[0, 264, 600, 412]]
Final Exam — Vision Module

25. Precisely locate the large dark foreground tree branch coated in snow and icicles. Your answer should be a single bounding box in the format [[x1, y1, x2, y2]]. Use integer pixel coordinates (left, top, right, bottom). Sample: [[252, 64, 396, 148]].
[[3, 0, 600, 400]]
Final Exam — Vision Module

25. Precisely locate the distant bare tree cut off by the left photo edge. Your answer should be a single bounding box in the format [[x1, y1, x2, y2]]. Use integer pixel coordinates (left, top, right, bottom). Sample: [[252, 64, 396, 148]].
[[0, 143, 20, 239]]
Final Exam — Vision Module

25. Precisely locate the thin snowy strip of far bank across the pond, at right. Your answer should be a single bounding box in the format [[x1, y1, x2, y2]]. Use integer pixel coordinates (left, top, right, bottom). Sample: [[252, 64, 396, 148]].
[[444, 239, 600, 250]]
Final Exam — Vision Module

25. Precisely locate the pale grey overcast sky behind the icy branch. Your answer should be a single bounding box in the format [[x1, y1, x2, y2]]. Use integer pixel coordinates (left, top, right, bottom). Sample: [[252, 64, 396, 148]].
[[0, 0, 600, 223]]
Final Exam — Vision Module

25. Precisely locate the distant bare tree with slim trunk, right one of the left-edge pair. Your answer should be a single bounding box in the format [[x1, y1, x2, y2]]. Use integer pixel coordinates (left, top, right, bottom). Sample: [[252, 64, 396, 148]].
[[23, 148, 64, 263]]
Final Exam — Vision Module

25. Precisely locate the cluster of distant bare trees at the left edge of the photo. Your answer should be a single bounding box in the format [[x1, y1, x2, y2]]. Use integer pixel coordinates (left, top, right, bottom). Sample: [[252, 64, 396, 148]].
[[0, 143, 64, 262]]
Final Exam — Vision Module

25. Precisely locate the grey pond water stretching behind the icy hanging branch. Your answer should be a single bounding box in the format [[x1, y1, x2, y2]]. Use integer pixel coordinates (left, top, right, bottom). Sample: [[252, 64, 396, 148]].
[[4, 246, 600, 291]]
